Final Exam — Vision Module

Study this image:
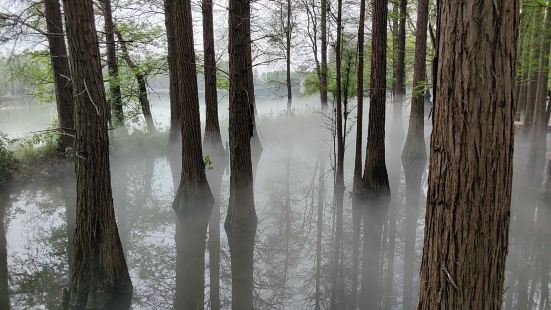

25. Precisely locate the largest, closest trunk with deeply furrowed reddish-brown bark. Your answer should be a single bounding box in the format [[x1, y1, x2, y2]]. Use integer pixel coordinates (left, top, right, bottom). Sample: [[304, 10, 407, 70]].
[[418, 0, 519, 309]]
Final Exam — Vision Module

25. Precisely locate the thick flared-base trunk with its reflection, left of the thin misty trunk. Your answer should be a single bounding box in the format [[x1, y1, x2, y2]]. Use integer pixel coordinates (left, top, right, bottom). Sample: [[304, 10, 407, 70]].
[[167, 0, 214, 309]]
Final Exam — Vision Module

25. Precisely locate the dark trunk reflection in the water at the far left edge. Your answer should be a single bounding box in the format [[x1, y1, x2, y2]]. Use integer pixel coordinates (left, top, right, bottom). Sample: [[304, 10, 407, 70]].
[[0, 186, 10, 310]]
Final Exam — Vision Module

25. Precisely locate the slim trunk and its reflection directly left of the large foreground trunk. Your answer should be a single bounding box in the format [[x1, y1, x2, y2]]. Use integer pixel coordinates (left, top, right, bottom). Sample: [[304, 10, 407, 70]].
[[402, 0, 429, 309]]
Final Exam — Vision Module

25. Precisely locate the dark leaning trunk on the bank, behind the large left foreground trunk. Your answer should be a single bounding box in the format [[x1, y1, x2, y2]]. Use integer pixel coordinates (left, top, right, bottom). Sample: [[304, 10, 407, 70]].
[[44, 0, 75, 153]]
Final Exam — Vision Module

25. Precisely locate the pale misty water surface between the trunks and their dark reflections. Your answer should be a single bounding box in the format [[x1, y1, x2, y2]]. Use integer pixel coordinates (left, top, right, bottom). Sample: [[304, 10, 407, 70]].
[[0, 98, 551, 309]]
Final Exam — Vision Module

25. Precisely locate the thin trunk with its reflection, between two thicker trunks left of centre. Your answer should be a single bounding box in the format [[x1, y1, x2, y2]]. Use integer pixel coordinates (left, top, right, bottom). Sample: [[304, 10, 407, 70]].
[[201, 0, 227, 310]]
